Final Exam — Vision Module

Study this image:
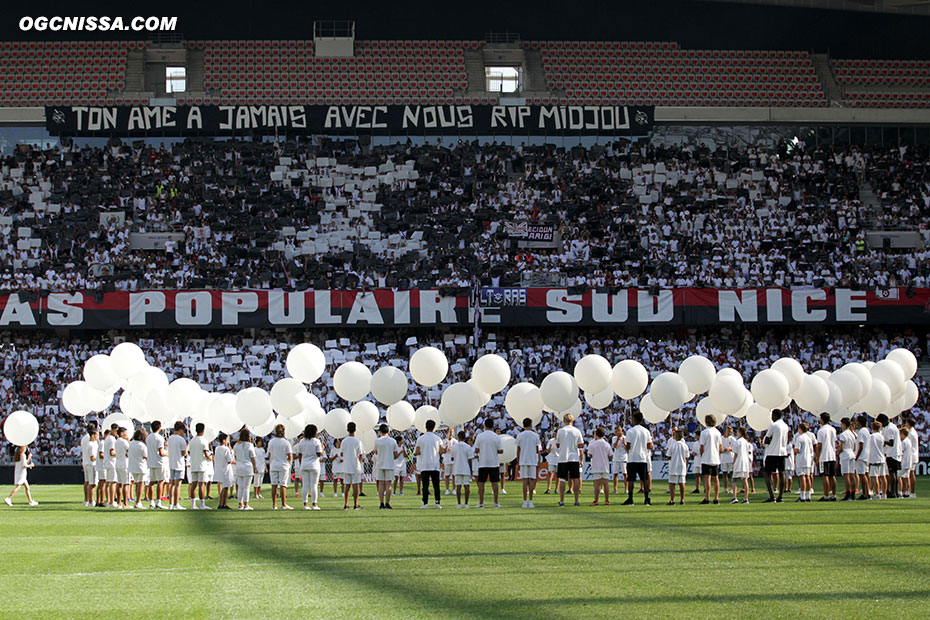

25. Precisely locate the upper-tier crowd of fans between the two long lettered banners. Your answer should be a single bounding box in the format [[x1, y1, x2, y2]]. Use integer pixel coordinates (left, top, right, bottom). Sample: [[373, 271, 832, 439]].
[[0, 139, 930, 291]]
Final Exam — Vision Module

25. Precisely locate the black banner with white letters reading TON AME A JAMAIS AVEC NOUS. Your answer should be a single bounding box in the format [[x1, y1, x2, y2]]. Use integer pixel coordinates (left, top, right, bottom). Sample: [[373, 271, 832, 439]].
[[45, 104, 655, 137]]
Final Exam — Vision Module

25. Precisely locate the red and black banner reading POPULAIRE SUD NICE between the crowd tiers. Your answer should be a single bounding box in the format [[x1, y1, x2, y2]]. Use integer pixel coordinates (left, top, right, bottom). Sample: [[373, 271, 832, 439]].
[[0, 288, 930, 329]]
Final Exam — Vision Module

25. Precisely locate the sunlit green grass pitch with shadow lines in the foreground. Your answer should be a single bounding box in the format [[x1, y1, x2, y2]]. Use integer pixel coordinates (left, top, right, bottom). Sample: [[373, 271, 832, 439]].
[[0, 481, 930, 620]]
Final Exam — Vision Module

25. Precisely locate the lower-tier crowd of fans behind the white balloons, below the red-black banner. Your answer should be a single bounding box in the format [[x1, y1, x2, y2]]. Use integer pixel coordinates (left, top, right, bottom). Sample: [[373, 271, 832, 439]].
[[0, 327, 930, 464]]
